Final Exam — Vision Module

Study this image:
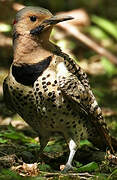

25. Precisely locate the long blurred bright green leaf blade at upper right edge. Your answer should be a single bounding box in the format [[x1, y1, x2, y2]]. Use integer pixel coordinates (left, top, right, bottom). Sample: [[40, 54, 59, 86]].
[[91, 15, 117, 40]]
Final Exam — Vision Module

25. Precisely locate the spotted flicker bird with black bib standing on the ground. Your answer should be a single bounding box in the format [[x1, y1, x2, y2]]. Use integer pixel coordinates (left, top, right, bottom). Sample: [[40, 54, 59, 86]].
[[3, 6, 116, 172]]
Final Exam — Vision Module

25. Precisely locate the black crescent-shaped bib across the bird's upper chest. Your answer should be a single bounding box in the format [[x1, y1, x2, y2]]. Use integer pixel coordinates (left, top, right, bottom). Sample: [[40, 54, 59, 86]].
[[12, 56, 52, 86]]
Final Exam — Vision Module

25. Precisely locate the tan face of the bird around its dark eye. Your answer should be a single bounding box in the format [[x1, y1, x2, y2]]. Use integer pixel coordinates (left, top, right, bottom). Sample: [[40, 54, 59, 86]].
[[14, 12, 51, 34]]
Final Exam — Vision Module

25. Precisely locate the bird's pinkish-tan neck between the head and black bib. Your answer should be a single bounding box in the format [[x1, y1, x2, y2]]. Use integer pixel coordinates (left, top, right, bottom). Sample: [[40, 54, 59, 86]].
[[13, 29, 55, 65]]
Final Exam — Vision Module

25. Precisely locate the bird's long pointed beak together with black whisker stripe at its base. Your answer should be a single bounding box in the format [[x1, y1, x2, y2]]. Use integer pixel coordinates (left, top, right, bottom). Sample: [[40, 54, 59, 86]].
[[30, 15, 74, 35]]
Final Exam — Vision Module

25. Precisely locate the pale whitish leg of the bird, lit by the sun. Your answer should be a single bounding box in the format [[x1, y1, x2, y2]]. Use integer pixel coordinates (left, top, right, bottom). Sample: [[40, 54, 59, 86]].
[[62, 139, 78, 173]]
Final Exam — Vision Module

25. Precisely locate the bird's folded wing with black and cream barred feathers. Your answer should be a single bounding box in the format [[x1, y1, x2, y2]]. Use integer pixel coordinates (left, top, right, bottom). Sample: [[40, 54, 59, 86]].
[[55, 52, 114, 152]]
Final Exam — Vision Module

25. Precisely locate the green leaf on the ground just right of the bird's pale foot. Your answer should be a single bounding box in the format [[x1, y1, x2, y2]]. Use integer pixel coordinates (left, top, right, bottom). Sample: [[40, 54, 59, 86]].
[[77, 162, 99, 172]]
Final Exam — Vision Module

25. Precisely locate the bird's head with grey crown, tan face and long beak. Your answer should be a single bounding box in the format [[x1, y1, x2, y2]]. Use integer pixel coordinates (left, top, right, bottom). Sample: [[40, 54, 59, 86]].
[[14, 6, 73, 36]]
